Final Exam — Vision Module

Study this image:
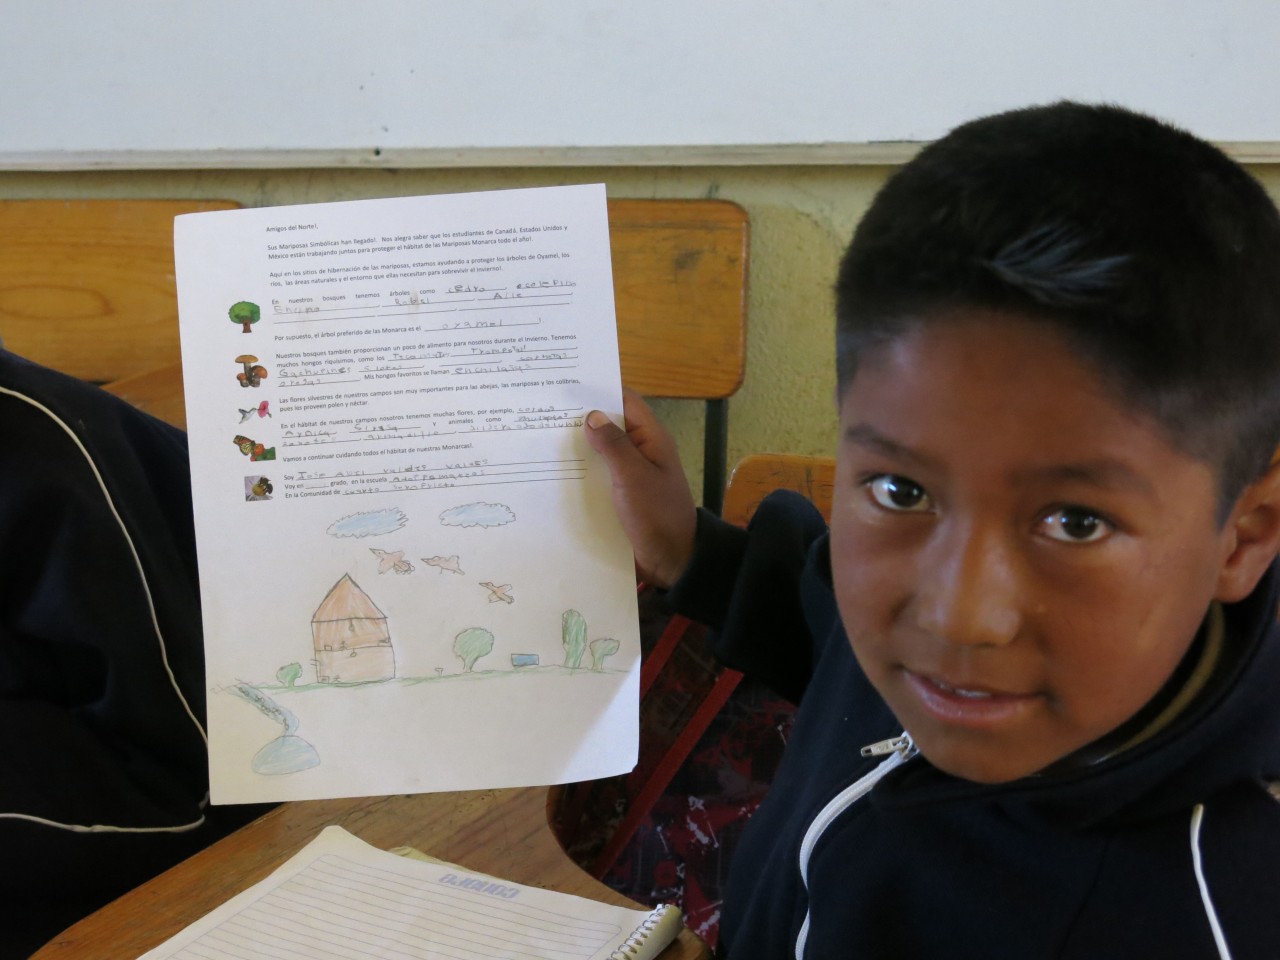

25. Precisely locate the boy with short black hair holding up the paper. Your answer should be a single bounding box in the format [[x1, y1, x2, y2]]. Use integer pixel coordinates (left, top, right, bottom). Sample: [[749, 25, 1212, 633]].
[[588, 104, 1280, 960]]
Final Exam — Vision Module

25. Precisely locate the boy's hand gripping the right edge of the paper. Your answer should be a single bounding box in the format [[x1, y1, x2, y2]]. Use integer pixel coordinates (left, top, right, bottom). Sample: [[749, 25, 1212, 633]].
[[586, 389, 698, 588]]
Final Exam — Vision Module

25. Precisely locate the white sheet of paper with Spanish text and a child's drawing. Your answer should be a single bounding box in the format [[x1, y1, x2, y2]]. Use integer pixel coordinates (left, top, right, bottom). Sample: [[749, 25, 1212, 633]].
[[174, 184, 640, 803]]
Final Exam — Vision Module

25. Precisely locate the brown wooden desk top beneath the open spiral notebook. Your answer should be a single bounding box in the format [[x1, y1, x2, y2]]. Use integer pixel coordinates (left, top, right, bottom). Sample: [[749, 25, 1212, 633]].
[[32, 787, 710, 960]]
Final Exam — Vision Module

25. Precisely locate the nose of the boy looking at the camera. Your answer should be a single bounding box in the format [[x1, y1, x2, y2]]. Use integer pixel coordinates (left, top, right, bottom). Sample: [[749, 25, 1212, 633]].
[[915, 526, 1021, 646]]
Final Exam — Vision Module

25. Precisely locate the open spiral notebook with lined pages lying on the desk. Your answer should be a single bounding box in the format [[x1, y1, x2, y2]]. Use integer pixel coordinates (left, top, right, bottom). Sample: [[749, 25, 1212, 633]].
[[140, 827, 682, 960]]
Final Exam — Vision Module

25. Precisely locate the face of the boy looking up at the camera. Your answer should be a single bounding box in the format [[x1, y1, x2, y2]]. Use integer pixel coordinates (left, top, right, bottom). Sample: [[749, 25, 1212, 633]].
[[831, 311, 1235, 782]]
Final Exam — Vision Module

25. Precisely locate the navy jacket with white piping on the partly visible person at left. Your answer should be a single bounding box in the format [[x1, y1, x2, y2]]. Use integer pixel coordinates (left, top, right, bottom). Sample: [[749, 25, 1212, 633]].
[[0, 349, 270, 957]]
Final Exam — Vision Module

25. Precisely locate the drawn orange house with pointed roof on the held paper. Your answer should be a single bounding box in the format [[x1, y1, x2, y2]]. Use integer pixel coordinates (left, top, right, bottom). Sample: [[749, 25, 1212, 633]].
[[311, 573, 396, 684]]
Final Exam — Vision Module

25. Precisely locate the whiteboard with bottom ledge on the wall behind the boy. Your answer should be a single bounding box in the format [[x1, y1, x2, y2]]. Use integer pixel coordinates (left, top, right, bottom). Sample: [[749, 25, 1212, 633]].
[[0, 0, 1280, 169]]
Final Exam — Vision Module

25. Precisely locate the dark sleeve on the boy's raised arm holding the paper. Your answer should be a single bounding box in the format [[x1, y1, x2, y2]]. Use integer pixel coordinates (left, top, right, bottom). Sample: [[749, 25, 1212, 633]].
[[668, 490, 827, 703]]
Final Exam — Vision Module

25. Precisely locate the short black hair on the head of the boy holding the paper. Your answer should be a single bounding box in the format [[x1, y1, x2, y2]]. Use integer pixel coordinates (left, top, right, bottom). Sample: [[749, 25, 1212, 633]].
[[836, 102, 1280, 516]]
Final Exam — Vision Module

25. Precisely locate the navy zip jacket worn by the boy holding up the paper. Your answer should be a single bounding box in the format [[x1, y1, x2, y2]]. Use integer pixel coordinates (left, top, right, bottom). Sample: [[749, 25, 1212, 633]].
[[669, 493, 1280, 960]]
